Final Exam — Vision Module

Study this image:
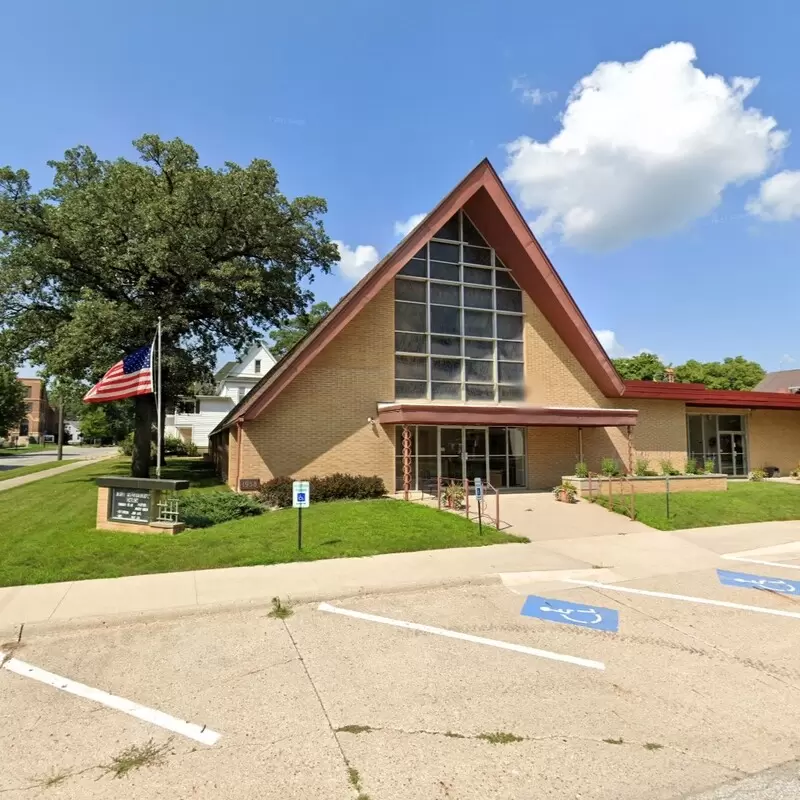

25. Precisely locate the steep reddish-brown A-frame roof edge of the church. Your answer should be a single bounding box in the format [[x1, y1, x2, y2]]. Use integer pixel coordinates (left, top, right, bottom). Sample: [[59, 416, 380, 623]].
[[214, 159, 625, 432]]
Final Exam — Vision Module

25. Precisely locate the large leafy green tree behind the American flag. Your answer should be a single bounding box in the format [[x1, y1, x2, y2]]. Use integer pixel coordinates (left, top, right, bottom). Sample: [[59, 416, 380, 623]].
[[0, 134, 339, 476]]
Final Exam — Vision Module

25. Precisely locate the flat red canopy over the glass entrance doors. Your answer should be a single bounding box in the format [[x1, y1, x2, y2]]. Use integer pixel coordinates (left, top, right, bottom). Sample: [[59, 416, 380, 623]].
[[378, 403, 639, 428]]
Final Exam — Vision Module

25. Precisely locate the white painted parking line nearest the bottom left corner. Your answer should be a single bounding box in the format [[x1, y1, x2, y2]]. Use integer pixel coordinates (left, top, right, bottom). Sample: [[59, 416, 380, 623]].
[[0, 651, 220, 747]]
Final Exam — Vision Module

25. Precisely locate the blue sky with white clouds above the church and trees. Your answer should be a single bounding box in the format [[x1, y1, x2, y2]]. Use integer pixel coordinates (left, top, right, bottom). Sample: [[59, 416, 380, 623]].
[[6, 0, 800, 376]]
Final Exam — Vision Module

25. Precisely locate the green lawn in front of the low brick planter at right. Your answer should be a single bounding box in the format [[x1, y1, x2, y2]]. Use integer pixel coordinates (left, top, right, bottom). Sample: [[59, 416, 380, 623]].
[[599, 481, 800, 531]]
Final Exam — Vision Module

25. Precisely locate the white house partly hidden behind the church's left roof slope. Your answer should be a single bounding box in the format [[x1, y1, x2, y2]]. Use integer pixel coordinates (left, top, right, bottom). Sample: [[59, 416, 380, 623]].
[[164, 342, 276, 447]]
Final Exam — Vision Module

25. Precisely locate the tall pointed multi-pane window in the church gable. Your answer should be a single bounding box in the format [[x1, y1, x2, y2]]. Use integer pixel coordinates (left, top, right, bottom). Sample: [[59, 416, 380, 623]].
[[394, 211, 525, 402]]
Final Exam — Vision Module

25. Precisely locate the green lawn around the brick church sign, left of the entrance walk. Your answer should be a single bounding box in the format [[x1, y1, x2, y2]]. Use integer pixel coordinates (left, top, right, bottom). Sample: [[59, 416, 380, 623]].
[[0, 459, 520, 586]]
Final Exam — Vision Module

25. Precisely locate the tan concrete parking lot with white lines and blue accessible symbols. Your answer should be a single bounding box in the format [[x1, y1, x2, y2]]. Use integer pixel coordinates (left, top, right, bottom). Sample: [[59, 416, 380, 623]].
[[0, 554, 800, 800]]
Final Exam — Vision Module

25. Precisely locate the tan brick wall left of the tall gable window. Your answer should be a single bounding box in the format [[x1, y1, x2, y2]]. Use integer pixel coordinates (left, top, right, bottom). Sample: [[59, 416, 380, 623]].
[[241, 283, 394, 491]]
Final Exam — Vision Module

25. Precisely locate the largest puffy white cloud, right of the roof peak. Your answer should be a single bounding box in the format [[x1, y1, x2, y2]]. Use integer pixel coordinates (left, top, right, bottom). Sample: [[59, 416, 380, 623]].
[[503, 42, 788, 249]]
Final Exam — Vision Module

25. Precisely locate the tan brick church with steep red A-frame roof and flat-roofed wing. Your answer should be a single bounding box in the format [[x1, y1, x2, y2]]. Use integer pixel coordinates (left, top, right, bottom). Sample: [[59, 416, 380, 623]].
[[210, 161, 800, 490]]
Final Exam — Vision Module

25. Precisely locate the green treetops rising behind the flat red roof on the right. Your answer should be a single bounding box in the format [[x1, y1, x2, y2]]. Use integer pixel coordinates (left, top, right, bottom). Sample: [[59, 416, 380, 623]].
[[613, 353, 766, 391]]
